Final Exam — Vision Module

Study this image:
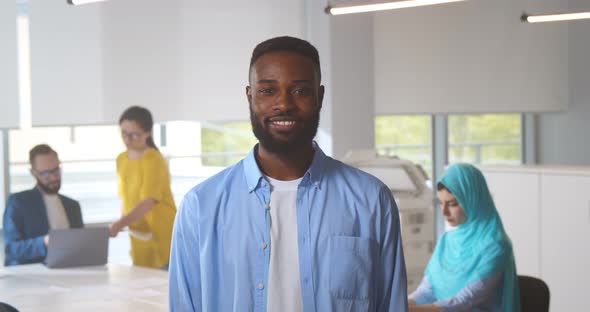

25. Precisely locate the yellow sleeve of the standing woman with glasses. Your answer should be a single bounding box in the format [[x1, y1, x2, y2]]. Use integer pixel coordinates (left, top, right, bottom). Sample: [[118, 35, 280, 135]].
[[139, 152, 168, 201]]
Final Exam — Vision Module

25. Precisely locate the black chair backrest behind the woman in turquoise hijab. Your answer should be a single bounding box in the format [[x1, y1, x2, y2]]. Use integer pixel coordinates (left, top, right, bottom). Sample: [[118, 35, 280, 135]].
[[518, 275, 549, 312]]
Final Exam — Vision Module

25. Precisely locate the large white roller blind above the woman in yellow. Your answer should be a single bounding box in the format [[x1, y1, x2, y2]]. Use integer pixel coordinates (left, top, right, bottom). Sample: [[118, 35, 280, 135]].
[[30, 0, 304, 126]]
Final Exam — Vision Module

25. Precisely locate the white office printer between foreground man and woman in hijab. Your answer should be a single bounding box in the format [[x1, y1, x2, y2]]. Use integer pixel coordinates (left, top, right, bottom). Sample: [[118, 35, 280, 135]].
[[342, 150, 435, 294]]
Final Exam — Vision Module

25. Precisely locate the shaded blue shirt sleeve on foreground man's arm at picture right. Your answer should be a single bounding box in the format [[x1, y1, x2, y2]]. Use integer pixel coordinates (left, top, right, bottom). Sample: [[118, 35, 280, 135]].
[[377, 186, 408, 312]]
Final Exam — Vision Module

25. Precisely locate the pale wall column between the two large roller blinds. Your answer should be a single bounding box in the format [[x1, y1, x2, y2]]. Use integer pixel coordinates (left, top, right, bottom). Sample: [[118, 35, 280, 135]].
[[305, 0, 375, 158]]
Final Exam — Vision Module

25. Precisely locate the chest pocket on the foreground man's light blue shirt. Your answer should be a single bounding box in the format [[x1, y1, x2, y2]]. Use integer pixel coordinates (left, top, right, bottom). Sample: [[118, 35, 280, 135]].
[[328, 236, 377, 301]]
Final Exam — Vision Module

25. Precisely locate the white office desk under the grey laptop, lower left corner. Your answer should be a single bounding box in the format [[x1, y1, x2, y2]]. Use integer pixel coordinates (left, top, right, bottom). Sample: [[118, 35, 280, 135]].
[[0, 263, 168, 312]]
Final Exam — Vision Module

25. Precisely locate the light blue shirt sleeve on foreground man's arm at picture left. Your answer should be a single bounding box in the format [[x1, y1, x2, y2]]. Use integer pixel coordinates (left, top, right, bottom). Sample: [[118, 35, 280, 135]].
[[169, 193, 203, 312]]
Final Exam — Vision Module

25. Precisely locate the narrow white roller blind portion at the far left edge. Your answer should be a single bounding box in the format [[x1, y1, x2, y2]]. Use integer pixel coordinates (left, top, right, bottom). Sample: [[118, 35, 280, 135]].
[[0, 1, 19, 128]]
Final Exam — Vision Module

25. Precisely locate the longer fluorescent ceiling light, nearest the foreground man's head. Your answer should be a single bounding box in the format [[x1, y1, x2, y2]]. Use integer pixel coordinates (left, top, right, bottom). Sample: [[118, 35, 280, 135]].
[[326, 0, 465, 15]]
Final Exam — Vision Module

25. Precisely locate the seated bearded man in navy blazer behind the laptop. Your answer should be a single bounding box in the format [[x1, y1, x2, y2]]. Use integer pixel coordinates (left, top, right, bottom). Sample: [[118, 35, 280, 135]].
[[2, 144, 83, 266]]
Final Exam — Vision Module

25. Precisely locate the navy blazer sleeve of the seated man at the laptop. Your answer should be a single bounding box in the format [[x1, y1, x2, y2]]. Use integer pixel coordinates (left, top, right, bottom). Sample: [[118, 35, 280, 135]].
[[2, 196, 47, 265]]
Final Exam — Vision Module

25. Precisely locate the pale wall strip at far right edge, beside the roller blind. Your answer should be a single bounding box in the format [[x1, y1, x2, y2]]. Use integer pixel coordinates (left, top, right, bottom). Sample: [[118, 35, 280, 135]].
[[537, 0, 590, 165]]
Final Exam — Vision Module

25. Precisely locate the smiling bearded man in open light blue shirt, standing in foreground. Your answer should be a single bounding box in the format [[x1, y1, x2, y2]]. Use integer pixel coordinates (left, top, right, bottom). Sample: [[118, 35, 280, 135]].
[[170, 37, 407, 311]]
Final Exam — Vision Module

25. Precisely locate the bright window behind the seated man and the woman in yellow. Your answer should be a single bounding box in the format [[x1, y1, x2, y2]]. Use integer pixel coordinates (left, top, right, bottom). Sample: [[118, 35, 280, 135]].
[[9, 122, 256, 223]]
